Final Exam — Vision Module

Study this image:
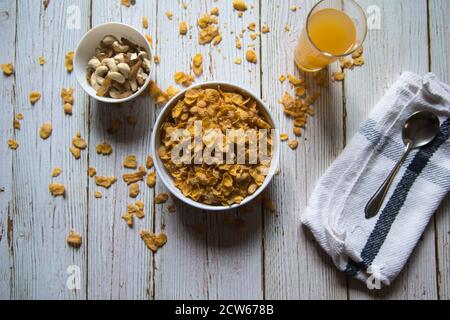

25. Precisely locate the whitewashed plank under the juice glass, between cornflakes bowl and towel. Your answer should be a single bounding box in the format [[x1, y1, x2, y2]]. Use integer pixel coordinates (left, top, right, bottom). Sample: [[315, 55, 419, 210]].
[[261, 0, 347, 299]]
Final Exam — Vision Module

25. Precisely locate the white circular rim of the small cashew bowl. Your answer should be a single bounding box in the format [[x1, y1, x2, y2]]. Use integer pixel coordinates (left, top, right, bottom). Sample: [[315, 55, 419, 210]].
[[73, 22, 154, 103]]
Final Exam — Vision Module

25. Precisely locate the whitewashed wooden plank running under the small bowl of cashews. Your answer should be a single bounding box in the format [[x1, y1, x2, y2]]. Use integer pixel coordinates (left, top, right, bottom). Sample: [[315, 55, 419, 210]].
[[88, 0, 157, 299]]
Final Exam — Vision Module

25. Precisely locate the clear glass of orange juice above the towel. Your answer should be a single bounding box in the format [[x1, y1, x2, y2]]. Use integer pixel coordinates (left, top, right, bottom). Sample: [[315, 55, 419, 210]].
[[295, 0, 367, 72]]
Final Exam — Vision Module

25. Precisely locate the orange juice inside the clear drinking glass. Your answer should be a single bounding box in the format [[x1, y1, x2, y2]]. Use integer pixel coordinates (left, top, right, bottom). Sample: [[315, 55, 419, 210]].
[[295, 8, 357, 72]]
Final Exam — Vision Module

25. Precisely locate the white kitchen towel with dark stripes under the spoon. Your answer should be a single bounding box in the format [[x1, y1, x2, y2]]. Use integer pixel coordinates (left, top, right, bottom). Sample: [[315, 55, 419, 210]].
[[301, 72, 450, 285]]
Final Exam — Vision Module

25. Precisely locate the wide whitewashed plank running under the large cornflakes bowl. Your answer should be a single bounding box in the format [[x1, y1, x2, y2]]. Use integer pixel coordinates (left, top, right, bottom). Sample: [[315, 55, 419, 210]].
[[155, 0, 263, 299]]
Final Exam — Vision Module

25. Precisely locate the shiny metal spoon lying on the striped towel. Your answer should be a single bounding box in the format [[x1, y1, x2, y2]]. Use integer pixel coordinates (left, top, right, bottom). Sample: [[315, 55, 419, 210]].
[[364, 111, 440, 219]]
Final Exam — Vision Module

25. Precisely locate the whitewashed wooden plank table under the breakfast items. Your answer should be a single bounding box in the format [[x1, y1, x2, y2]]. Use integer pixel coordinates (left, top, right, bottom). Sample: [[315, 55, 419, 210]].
[[0, 0, 450, 299]]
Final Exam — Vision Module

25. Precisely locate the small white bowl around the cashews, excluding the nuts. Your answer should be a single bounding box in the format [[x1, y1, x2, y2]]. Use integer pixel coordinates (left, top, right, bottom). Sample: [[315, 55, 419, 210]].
[[74, 22, 153, 103]]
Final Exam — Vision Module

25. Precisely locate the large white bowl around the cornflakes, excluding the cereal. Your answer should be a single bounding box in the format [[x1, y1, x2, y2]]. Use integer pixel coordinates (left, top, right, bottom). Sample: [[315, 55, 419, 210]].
[[151, 81, 280, 211]]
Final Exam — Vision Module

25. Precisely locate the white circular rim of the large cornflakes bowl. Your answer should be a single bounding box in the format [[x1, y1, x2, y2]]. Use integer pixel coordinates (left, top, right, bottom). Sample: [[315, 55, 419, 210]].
[[150, 81, 281, 211]]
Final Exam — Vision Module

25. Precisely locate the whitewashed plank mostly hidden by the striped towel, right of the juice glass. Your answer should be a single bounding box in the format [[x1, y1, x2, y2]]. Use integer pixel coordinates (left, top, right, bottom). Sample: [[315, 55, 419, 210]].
[[345, 0, 437, 299]]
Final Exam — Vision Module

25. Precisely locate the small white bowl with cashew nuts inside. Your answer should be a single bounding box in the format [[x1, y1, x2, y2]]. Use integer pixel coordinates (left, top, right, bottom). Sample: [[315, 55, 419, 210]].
[[74, 23, 152, 103]]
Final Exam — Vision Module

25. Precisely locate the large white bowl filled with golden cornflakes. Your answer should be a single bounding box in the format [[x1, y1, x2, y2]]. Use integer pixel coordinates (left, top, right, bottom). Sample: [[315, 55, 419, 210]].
[[152, 82, 280, 211]]
